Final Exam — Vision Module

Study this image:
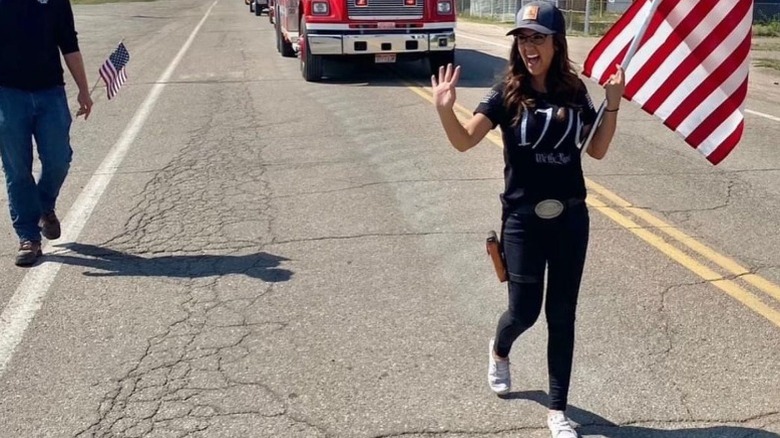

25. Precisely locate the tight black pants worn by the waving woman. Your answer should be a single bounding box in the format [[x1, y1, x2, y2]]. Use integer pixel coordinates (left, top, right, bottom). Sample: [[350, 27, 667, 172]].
[[495, 203, 590, 411]]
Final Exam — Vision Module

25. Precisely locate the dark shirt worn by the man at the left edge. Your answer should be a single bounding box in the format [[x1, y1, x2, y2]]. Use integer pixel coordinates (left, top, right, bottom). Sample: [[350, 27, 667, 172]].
[[0, 0, 79, 91]]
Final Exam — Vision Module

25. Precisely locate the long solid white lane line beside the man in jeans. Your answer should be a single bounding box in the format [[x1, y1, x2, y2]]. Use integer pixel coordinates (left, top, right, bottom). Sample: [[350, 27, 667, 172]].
[[0, 0, 219, 374]]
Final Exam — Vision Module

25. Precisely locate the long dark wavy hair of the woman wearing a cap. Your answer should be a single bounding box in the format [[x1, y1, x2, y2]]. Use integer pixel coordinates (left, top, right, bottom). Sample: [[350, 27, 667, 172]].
[[504, 33, 580, 126]]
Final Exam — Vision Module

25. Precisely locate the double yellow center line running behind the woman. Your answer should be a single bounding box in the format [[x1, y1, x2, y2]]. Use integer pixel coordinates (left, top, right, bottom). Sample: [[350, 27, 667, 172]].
[[406, 82, 780, 327]]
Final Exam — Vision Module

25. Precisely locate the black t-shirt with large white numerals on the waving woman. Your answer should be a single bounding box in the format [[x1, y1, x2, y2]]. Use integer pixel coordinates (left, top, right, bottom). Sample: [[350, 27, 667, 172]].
[[474, 81, 596, 211]]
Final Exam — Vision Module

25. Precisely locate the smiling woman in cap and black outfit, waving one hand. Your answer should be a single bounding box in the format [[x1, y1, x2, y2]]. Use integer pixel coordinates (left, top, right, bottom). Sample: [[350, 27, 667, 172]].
[[431, 2, 625, 438]]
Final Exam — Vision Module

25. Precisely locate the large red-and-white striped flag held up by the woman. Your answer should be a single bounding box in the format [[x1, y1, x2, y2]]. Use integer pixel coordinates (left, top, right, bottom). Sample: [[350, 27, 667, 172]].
[[583, 0, 753, 164]]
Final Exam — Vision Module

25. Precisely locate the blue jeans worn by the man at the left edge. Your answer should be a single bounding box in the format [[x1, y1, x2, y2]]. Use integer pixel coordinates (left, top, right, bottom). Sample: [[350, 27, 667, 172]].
[[0, 86, 73, 241]]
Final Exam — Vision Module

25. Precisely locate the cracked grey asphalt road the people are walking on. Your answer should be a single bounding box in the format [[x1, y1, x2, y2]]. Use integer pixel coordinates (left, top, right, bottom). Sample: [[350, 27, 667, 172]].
[[0, 0, 780, 438]]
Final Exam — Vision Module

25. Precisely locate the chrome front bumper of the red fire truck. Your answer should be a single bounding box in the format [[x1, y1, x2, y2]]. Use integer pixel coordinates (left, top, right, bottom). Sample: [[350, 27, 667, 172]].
[[307, 32, 455, 55]]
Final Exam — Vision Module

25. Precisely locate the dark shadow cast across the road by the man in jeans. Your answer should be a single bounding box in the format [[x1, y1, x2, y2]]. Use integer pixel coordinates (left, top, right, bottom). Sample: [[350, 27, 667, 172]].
[[42, 243, 293, 283]]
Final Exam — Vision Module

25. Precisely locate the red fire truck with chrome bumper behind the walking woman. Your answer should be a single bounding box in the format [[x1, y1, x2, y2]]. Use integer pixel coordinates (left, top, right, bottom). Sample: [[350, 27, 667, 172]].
[[273, 0, 456, 81]]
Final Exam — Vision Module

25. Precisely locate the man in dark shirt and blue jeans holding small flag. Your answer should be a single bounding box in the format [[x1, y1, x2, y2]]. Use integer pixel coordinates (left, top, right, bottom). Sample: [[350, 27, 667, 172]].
[[0, 0, 92, 266]]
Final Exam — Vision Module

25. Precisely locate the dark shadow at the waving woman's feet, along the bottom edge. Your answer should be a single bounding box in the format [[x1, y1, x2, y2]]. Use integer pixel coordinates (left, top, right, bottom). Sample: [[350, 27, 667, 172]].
[[502, 391, 780, 438]]
